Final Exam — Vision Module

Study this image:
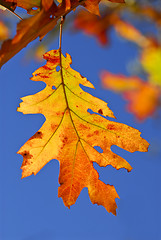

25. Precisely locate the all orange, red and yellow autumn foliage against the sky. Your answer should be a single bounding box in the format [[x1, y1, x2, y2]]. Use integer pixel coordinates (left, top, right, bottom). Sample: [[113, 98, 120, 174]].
[[0, 0, 161, 214]]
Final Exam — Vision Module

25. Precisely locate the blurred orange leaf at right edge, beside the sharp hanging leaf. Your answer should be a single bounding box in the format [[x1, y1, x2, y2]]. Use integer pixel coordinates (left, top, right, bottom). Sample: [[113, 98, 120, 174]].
[[101, 71, 161, 120]]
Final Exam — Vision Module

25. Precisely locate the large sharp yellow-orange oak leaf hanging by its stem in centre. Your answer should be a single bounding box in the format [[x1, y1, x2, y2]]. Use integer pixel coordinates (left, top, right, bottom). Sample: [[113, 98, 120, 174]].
[[18, 50, 149, 214]]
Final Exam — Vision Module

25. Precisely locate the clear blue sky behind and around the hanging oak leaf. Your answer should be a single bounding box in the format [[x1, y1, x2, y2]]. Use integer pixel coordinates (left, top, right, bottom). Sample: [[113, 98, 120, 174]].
[[0, 12, 161, 240]]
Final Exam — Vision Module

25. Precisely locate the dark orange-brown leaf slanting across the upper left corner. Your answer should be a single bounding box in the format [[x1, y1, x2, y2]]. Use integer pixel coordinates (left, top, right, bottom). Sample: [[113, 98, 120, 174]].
[[0, 4, 59, 68]]
